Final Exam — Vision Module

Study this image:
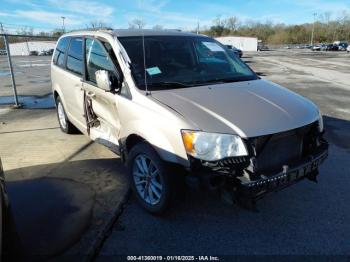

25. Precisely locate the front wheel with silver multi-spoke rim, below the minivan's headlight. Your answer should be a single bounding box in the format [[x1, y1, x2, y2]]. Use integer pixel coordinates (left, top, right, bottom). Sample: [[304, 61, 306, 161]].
[[127, 142, 173, 214]]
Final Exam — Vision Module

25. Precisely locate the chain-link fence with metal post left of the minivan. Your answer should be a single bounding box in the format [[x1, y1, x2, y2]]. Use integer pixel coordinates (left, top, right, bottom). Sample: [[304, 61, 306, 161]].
[[0, 34, 57, 106]]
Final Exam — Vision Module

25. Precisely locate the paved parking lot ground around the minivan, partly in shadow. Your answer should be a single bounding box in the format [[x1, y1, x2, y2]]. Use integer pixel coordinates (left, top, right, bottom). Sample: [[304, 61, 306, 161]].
[[0, 50, 350, 261]]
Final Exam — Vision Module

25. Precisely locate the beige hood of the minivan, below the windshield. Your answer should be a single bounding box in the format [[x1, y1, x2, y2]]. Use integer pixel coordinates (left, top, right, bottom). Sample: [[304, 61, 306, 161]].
[[152, 80, 319, 138]]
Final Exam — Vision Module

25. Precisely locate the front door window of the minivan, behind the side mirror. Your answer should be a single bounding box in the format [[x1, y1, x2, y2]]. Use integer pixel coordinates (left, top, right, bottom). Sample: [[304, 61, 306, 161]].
[[85, 38, 115, 83]]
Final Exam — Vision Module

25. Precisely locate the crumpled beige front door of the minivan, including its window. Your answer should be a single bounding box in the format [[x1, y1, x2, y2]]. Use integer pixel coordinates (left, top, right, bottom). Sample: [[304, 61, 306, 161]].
[[83, 38, 120, 153]]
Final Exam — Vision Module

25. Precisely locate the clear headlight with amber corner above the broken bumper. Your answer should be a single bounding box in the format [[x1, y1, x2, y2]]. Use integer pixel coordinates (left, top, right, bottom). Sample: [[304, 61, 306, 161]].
[[181, 130, 248, 161]]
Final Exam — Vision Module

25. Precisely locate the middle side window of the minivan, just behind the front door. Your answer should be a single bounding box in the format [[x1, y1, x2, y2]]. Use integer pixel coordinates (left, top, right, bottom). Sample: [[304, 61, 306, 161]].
[[67, 37, 83, 75]]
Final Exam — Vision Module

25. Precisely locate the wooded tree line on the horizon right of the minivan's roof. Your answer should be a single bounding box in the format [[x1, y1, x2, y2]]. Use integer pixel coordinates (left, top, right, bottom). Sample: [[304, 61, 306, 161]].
[[201, 12, 350, 44]]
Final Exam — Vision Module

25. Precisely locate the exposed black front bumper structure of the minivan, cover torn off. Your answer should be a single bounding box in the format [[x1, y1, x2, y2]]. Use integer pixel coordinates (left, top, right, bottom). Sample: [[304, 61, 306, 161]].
[[192, 139, 328, 208]]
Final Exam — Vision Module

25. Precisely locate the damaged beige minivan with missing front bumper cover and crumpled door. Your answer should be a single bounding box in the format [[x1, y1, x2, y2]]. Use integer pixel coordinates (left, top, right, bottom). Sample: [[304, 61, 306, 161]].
[[51, 30, 328, 213]]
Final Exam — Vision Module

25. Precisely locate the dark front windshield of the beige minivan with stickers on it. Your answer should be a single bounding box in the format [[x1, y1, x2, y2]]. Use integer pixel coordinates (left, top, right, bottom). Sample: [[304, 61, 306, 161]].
[[118, 36, 258, 90]]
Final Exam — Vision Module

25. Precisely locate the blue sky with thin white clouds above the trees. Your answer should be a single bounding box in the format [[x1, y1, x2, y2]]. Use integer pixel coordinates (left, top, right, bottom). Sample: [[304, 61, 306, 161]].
[[0, 0, 350, 32]]
